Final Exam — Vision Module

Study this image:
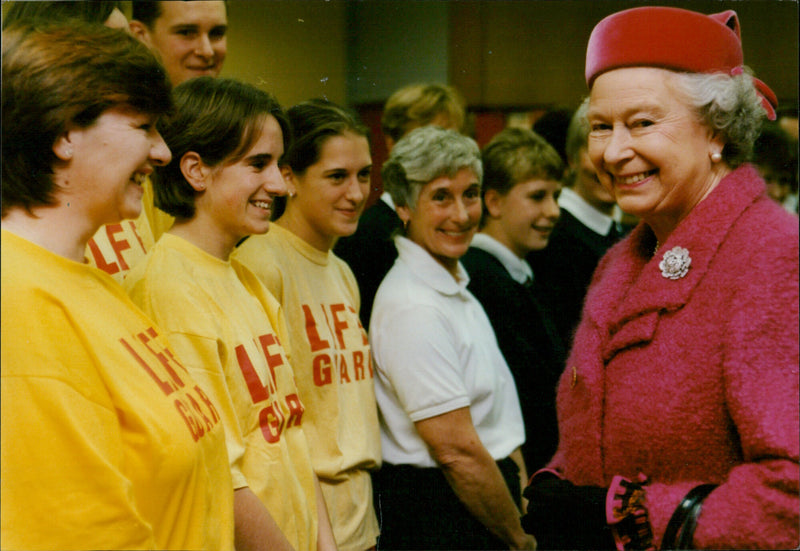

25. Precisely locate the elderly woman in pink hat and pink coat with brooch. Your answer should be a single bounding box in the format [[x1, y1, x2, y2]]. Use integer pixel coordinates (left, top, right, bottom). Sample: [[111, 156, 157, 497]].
[[523, 7, 800, 550]]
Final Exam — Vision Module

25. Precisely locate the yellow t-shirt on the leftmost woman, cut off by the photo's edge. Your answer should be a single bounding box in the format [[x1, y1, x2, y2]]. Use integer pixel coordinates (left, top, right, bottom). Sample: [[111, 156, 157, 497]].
[[0, 230, 233, 549]]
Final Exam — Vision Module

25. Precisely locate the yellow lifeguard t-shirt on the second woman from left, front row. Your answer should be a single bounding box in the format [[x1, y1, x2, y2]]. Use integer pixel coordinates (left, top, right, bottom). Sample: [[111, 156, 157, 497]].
[[125, 233, 318, 551]]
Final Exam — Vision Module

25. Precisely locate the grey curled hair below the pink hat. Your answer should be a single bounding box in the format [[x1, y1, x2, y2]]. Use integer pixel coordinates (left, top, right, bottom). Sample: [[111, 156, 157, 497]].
[[674, 69, 766, 168]]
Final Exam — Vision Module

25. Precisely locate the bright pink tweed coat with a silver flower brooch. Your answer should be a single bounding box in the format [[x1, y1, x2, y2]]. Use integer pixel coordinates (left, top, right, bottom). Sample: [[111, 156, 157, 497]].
[[549, 165, 800, 549]]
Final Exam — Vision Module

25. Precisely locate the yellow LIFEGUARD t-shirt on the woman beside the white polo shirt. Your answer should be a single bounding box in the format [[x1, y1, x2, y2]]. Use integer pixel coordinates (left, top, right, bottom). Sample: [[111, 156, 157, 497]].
[[233, 224, 381, 551]]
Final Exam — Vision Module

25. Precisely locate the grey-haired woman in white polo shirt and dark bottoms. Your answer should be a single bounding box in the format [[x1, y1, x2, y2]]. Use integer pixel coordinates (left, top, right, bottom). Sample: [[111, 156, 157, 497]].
[[370, 127, 535, 549]]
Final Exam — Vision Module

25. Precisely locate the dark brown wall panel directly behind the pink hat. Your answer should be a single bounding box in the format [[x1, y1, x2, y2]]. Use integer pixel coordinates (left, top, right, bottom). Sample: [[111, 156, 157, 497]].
[[450, 0, 798, 108]]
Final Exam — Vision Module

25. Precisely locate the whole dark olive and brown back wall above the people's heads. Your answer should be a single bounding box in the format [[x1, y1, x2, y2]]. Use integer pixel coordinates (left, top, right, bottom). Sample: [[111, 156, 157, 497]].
[[3, 0, 799, 200]]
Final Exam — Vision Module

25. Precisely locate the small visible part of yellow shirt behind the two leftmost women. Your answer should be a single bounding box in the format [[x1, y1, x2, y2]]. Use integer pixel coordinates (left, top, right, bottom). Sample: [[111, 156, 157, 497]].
[[86, 178, 174, 283]]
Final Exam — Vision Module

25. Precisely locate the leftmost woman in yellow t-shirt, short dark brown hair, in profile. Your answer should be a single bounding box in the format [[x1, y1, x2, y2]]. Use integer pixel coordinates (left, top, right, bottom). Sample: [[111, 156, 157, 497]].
[[0, 21, 233, 549]]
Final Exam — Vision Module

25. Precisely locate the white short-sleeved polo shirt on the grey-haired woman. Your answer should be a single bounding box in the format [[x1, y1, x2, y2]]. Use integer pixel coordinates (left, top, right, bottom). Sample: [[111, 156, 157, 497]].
[[369, 237, 525, 467]]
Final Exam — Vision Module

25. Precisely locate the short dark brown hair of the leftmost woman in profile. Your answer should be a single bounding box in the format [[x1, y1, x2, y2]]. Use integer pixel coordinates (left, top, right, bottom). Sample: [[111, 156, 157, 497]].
[[2, 20, 172, 214]]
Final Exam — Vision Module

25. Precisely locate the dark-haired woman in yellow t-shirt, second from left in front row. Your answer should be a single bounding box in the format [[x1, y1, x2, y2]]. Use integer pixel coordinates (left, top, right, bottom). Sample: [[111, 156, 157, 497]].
[[125, 77, 333, 551]]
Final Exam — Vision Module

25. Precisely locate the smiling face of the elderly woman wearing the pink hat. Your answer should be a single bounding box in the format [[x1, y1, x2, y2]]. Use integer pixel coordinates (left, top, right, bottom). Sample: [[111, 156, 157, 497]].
[[588, 67, 725, 230]]
